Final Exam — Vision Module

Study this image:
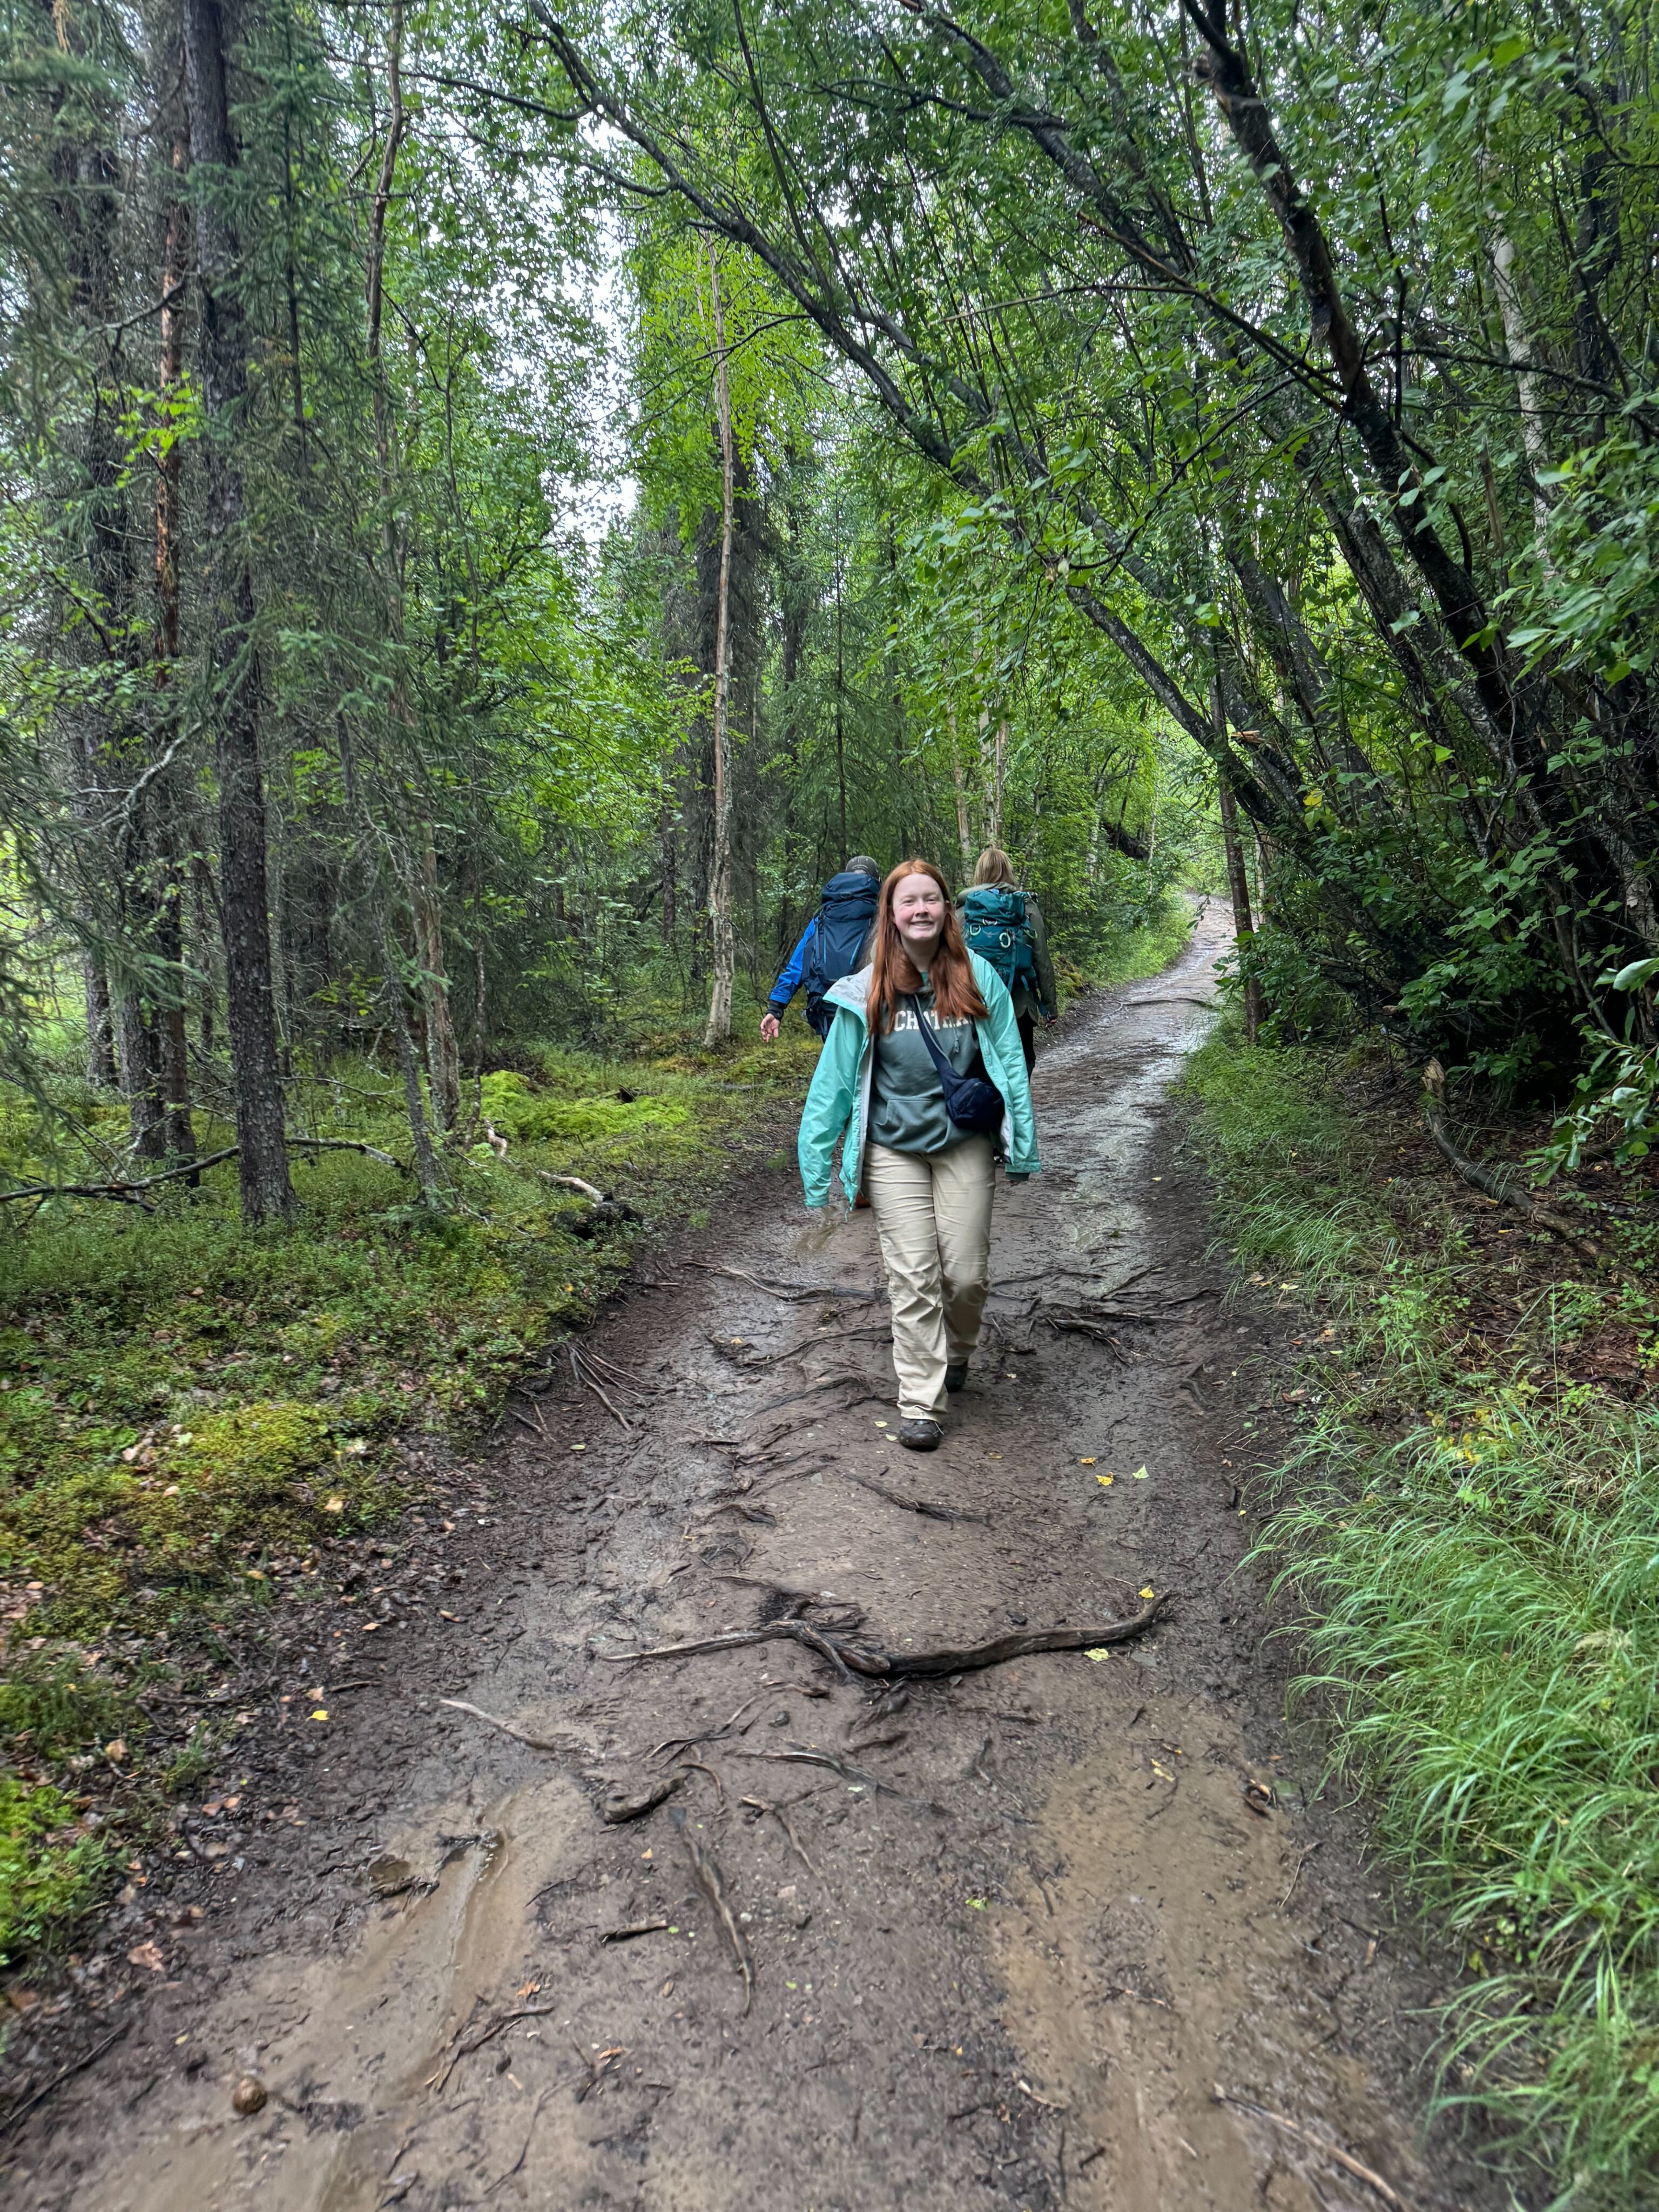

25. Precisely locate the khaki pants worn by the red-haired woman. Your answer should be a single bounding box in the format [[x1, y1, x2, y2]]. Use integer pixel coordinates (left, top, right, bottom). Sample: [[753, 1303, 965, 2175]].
[[865, 1137, 991, 1420]]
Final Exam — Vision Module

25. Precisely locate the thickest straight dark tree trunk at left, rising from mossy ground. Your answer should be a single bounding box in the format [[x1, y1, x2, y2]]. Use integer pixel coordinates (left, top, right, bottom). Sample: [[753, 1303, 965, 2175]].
[[184, 0, 299, 1223]]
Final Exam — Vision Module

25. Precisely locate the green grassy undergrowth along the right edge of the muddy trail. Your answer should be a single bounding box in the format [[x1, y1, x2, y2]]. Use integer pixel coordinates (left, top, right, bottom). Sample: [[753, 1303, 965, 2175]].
[[1190, 1033, 1659, 2212]]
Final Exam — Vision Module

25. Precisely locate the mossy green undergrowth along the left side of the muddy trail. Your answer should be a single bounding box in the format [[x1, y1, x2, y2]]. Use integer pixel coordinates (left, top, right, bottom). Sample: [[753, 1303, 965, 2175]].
[[0, 898, 1192, 1991]]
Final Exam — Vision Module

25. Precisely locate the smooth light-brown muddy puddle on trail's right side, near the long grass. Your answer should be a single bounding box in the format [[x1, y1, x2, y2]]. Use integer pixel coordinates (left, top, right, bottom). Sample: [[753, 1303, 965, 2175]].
[[993, 1659, 1422, 2212]]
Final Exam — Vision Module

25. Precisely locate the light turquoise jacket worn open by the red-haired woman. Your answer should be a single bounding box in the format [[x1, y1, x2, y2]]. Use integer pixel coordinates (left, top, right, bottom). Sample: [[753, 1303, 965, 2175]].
[[799, 953, 1042, 1205]]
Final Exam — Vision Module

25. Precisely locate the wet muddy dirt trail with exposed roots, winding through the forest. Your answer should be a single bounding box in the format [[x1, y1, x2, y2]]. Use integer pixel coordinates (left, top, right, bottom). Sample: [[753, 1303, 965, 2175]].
[[0, 916, 1495, 2212]]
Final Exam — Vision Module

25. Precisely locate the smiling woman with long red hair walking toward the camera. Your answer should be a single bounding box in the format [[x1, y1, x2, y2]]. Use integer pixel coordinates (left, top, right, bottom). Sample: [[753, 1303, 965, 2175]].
[[799, 860, 1040, 1451]]
